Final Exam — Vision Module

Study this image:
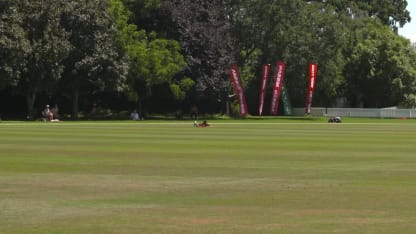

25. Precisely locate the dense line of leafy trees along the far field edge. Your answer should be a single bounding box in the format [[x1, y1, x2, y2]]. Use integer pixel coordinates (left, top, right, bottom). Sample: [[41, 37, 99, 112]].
[[0, 0, 416, 118]]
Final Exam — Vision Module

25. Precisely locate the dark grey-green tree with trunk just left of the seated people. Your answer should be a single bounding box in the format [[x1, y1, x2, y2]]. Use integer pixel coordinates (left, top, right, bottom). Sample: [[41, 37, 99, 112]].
[[14, 0, 70, 118]]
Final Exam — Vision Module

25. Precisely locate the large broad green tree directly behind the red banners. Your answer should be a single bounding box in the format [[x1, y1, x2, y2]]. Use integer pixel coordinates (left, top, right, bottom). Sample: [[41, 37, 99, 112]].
[[232, 0, 350, 106]]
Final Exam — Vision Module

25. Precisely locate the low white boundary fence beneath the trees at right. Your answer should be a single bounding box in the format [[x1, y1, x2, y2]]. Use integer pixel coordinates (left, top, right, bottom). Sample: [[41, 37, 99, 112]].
[[293, 107, 416, 118]]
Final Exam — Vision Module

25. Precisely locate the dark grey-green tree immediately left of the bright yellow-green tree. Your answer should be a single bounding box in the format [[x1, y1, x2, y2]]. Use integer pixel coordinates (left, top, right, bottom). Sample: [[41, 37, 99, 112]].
[[61, 0, 128, 119]]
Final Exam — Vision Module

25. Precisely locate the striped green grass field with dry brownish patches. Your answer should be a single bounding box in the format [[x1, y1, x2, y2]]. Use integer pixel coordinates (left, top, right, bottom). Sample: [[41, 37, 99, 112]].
[[0, 119, 416, 234]]
